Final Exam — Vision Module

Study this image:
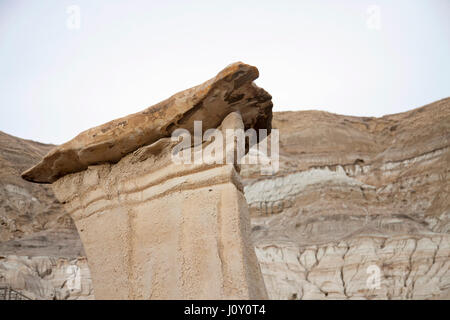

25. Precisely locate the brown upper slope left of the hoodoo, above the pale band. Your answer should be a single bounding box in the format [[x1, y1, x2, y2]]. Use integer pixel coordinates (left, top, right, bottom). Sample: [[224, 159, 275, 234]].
[[0, 132, 76, 247]]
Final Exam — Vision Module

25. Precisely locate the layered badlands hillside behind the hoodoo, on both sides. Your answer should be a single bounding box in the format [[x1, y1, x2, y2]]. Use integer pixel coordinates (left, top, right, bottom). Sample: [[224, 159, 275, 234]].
[[0, 98, 450, 299]]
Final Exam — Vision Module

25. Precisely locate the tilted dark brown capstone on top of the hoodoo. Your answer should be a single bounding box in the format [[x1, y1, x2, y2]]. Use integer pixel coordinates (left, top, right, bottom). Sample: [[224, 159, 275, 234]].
[[22, 62, 272, 183]]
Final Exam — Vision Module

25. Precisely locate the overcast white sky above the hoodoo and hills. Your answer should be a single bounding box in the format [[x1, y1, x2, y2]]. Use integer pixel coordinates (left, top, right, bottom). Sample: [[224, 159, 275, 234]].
[[0, 0, 450, 143]]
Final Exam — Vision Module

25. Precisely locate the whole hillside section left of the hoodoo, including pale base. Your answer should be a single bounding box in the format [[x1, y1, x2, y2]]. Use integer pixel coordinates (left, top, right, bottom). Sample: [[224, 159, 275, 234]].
[[0, 132, 89, 299]]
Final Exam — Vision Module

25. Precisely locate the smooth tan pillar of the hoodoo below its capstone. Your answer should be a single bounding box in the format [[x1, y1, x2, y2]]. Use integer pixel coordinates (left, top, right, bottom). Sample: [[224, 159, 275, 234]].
[[53, 113, 267, 299]]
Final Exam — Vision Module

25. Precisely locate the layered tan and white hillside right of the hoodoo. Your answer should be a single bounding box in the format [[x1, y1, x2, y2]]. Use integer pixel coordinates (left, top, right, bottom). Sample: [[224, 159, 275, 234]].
[[242, 99, 450, 299]]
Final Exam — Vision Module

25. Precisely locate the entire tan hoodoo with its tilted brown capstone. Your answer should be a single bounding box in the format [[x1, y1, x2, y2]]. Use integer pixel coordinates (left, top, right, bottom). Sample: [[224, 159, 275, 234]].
[[23, 63, 272, 299]]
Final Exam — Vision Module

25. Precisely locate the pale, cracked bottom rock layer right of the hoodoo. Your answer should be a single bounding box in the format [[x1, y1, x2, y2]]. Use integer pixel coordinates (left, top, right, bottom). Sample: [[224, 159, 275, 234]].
[[256, 234, 450, 300]]
